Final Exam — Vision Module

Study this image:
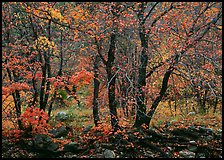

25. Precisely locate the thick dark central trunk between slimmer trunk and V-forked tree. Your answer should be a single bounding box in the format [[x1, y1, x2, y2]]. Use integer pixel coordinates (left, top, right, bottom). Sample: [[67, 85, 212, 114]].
[[106, 33, 120, 130]]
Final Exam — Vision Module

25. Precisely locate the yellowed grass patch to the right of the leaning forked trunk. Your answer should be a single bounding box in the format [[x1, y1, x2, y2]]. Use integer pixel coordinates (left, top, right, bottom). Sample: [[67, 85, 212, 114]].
[[151, 101, 222, 130]]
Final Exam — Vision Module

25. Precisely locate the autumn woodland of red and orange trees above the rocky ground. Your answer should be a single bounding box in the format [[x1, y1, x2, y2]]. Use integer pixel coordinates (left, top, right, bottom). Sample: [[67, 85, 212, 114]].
[[2, 2, 222, 159]]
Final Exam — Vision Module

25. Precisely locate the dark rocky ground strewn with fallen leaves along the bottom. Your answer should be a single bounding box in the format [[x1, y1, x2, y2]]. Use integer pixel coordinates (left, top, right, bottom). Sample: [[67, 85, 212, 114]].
[[2, 122, 222, 158]]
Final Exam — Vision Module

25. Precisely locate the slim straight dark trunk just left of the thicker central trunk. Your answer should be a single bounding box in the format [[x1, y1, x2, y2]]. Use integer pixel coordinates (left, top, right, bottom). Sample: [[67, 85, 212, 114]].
[[93, 55, 100, 127]]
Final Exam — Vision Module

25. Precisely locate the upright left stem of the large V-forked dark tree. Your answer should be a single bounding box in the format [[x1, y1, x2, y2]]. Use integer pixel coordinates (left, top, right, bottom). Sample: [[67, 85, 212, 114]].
[[133, 2, 173, 127]]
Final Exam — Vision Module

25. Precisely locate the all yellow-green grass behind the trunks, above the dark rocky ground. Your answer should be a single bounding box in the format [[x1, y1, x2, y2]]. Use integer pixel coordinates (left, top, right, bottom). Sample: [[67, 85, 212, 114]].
[[47, 97, 222, 134]]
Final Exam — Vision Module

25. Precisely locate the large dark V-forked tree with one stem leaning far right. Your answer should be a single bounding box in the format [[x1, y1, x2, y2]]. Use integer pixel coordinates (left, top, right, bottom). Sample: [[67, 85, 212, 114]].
[[130, 3, 221, 127]]
